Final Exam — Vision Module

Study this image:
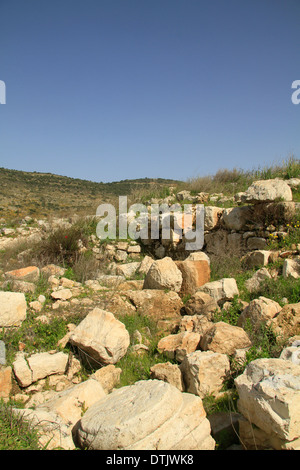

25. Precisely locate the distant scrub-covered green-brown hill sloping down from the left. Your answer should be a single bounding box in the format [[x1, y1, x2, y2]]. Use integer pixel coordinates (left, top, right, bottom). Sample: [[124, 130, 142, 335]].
[[0, 168, 181, 218]]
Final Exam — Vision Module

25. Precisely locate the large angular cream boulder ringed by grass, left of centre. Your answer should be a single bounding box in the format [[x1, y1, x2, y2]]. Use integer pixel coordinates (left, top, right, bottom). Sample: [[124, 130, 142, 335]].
[[70, 308, 130, 368]]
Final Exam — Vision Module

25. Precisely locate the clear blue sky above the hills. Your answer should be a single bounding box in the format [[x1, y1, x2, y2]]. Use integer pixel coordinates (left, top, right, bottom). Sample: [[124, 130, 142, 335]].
[[0, 0, 300, 182]]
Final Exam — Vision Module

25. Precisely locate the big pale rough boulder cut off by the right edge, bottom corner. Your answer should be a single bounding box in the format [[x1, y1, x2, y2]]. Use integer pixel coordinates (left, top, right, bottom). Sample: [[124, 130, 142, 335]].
[[235, 359, 300, 442]]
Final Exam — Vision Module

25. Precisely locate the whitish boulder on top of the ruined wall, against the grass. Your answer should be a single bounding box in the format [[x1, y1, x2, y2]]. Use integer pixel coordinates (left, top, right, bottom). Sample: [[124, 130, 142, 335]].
[[242, 178, 293, 204]]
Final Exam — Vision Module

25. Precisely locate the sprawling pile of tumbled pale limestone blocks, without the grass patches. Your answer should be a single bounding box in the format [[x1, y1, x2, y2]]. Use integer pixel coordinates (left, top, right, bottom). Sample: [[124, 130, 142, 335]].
[[0, 180, 300, 450]]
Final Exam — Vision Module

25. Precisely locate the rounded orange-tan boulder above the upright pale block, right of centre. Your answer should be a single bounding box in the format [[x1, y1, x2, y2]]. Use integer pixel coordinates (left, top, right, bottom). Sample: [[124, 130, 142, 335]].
[[200, 322, 251, 356]]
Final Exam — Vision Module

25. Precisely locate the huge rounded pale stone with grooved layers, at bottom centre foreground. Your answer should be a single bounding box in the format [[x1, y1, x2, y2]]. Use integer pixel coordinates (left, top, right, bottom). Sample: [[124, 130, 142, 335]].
[[76, 380, 215, 450]]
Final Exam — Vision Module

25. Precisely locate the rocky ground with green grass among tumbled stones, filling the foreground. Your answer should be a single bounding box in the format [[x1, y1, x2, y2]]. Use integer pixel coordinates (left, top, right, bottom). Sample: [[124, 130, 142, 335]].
[[0, 181, 300, 450]]
